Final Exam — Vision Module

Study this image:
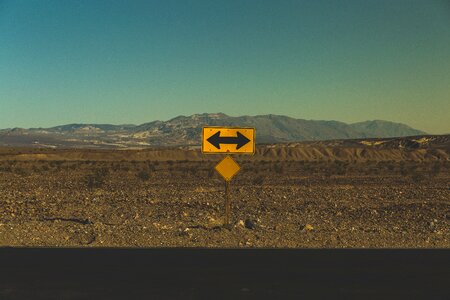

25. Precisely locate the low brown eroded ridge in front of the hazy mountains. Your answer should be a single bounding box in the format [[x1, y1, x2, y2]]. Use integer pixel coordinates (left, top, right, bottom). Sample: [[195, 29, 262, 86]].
[[0, 135, 450, 163]]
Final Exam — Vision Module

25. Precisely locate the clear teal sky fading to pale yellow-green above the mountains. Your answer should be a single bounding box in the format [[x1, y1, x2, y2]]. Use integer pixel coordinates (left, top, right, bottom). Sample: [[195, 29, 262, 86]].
[[0, 0, 450, 134]]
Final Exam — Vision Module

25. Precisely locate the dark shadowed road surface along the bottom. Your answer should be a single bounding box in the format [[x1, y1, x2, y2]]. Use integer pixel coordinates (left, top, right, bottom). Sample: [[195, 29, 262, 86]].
[[0, 248, 450, 299]]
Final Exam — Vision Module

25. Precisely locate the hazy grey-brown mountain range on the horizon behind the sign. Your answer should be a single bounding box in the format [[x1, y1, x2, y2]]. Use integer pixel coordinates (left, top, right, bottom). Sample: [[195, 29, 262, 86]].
[[0, 113, 426, 148]]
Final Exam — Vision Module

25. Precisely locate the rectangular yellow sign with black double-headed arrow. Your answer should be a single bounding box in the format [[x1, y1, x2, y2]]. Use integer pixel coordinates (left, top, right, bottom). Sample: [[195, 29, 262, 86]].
[[202, 127, 255, 154]]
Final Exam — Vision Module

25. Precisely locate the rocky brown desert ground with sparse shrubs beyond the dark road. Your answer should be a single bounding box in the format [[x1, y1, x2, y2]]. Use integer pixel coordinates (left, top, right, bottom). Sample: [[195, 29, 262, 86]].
[[0, 139, 450, 248]]
